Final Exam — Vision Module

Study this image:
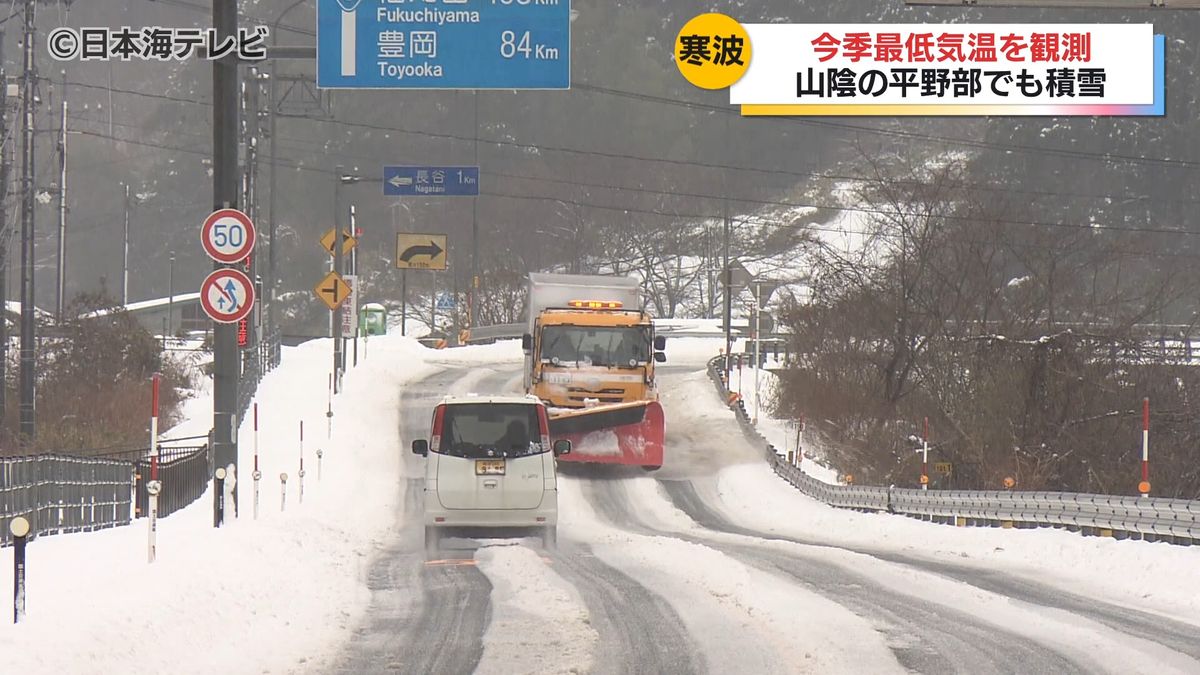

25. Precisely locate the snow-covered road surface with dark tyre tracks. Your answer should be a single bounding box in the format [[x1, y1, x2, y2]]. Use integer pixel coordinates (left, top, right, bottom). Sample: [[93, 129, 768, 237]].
[[319, 341, 1200, 673]]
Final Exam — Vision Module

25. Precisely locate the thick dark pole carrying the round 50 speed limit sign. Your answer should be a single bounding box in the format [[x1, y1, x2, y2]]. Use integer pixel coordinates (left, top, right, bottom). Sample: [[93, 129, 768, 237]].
[[212, 0, 242, 494]]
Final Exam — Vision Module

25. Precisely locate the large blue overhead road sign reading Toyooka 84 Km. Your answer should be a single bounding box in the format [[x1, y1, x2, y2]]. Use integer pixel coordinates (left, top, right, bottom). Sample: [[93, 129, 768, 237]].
[[317, 0, 571, 89]]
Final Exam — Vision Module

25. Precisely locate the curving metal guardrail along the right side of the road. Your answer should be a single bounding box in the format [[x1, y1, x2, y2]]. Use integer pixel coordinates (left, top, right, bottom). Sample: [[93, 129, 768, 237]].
[[708, 354, 1200, 545]]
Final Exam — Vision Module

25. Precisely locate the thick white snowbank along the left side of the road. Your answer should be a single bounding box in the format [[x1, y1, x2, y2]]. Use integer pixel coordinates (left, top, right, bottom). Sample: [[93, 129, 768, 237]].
[[0, 336, 451, 674]]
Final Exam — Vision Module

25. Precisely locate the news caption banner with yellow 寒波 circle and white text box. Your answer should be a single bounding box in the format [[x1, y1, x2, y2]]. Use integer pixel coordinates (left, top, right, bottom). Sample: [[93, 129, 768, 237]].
[[674, 13, 1166, 117]]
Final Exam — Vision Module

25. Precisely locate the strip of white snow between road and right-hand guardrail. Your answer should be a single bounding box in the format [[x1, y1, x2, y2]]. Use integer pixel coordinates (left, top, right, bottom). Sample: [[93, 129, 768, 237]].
[[664, 362, 1200, 623]]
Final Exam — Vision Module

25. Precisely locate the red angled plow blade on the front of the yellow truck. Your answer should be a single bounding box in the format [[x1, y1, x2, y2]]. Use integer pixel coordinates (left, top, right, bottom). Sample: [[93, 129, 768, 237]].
[[550, 401, 665, 470]]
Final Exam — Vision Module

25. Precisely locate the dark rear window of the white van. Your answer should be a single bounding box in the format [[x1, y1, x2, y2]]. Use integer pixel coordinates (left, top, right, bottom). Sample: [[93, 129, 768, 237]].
[[440, 404, 550, 458]]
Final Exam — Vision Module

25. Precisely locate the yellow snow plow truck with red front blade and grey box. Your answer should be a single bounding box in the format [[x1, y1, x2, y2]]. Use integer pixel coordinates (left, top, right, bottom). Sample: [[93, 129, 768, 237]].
[[521, 274, 666, 470]]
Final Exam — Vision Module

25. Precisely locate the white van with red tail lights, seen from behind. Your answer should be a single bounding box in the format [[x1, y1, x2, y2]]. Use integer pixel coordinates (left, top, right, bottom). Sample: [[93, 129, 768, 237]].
[[413, 394, 571, 554]]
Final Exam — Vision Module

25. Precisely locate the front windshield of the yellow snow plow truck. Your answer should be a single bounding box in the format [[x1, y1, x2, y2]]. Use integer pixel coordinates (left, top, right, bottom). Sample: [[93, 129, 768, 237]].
[[541, 325, 650, 368]]
